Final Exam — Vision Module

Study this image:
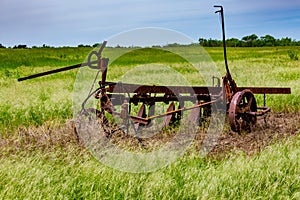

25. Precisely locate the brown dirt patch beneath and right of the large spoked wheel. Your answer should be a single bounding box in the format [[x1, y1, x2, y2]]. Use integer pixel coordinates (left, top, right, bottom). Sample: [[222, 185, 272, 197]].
[[209, 112, 300, 157]]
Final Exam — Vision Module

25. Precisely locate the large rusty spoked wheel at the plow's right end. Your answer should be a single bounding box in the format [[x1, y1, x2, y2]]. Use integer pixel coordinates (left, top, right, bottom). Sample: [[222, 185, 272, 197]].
[[229, 89, 257, 133]]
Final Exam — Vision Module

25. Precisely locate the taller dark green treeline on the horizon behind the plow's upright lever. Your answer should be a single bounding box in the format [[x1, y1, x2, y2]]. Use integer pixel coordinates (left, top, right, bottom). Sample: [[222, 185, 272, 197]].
[[199, 34, 300, 47]]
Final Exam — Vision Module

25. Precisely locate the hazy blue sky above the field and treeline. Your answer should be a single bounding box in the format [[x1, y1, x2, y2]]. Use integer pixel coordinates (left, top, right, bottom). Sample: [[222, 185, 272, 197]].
[[0, 0, 300, 47]]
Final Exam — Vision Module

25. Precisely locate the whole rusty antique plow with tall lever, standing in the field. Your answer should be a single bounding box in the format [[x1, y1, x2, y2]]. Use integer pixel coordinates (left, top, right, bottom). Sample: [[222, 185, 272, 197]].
[[18, 6, 291, 142]]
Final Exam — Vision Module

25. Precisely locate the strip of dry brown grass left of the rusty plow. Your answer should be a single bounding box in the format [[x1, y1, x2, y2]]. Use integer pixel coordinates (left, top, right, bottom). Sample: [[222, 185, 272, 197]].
[[0, 120, 80, 156]]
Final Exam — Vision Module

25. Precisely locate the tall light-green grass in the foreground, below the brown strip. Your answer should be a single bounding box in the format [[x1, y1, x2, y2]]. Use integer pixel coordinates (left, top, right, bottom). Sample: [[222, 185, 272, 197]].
[[0, 136, 300, 199]]
